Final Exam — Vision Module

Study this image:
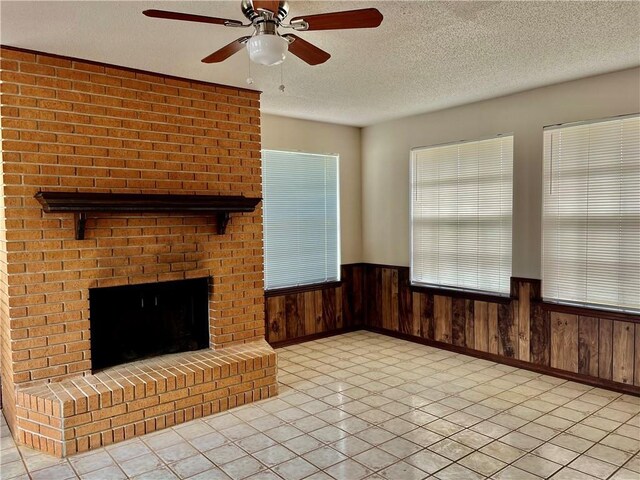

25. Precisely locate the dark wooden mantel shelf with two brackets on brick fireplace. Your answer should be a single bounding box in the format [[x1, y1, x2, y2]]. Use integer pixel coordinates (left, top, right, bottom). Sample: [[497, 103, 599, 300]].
[[35, 192, 262, 240]]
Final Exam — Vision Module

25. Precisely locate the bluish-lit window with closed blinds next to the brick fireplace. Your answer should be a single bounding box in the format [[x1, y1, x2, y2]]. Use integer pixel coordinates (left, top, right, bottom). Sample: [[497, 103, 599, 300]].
[[262, 150, 340, 289]]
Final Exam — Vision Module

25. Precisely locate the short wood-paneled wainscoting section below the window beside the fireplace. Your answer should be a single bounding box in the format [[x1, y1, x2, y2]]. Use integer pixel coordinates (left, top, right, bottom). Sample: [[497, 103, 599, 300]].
[[266, 264, 364, 345]]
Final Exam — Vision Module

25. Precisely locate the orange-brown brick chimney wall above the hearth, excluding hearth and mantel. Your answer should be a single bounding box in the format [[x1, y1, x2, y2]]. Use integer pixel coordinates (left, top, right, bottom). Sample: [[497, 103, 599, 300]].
[[0, 48, 264, 432]]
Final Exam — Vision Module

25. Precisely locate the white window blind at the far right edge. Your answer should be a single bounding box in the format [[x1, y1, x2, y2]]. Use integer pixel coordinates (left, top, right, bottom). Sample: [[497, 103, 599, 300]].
[[542, 115, 640, 313]]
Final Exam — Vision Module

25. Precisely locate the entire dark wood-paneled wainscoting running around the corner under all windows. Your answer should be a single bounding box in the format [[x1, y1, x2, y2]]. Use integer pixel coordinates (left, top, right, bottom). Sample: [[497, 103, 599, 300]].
[[266, 264, 640, 395]]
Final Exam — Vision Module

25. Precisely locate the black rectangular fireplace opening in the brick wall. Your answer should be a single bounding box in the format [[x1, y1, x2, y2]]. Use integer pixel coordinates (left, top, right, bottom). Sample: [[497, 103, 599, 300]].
[[89, 277, 209, 372]]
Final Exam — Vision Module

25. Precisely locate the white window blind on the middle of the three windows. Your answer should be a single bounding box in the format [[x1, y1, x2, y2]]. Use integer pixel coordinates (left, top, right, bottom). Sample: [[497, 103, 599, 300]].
[[411, 135, 513, 294]]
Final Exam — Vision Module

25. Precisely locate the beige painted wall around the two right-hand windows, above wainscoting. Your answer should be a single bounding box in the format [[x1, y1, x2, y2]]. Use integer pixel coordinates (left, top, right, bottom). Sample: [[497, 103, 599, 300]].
[[362, 68, 640, 278]]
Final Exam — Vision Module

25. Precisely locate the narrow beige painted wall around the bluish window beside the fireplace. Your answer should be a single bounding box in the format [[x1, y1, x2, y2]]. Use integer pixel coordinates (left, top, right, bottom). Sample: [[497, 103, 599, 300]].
[[261, 113, 362, 264]]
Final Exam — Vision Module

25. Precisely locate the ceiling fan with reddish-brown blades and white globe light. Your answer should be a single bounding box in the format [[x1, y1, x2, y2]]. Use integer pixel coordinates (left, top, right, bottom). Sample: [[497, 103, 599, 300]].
[[142, 0, 382, 65]]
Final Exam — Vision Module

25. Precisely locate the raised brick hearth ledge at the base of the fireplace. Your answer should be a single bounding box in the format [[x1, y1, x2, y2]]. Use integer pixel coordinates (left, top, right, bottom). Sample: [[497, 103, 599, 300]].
[[16, 340, 277, 457]]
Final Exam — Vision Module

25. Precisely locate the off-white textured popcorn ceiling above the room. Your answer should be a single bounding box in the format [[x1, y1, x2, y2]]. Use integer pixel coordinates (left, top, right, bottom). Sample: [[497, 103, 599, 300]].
[[0, 0, 640, 126]]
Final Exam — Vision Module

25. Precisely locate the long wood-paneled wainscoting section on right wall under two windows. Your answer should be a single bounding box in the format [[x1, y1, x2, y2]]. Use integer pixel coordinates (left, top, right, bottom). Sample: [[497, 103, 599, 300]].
[[364, 264, 640, 393]]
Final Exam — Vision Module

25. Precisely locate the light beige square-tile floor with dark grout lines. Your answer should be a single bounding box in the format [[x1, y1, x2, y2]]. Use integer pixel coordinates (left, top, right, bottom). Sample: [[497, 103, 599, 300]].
[[0, 332, 640, 480]]
